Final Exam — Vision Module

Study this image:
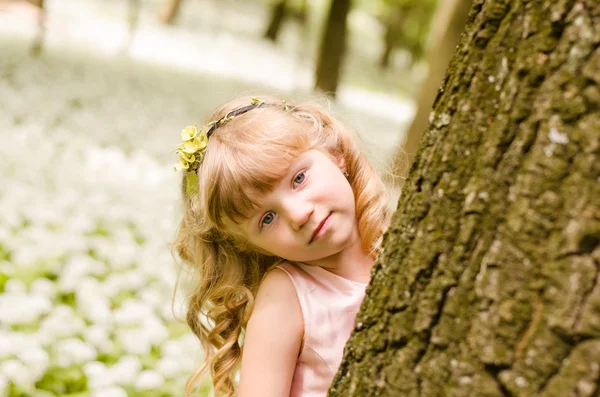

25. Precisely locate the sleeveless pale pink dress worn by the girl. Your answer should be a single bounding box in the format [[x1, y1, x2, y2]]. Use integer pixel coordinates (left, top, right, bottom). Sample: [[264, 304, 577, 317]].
[[277, 262, 367, 397]]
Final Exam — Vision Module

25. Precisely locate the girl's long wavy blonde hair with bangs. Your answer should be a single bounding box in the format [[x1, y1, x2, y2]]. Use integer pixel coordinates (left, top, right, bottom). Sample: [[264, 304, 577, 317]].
[[173, 97, 389, 396]]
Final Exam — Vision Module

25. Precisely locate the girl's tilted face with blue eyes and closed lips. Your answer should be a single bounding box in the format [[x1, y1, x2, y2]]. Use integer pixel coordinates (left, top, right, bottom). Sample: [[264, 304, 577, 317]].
[[231, 150, 360, 262]]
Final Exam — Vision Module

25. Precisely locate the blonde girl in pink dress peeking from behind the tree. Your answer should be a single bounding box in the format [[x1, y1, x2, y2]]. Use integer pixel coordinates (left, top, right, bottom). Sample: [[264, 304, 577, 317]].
[[174, 97, 389, 397]]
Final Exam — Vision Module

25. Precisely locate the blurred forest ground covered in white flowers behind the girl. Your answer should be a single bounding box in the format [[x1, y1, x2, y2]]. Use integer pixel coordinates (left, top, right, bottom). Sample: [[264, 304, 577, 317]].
[[0, 1, 410, 397]]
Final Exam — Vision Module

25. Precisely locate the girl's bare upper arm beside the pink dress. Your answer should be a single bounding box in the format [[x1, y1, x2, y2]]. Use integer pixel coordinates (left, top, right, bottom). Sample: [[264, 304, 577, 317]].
[[239, 268, 304, 397]]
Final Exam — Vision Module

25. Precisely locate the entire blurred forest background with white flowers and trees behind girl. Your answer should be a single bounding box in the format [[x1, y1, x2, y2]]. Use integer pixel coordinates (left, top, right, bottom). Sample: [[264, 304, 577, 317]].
[[0, 0, 470, 397]]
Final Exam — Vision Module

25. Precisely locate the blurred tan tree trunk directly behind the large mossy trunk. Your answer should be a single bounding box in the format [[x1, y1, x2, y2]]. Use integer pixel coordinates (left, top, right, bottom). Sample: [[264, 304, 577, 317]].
[[387, 0, 473, 184]]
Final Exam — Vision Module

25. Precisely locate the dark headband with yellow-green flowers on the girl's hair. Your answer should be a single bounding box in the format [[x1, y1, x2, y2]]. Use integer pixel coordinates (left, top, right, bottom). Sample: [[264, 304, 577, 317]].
[[175, 97, 290, 197]]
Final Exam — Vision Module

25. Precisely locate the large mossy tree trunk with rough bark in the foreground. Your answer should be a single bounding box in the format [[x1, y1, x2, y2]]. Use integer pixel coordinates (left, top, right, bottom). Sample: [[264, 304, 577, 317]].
[[329, 0, 600, 397]]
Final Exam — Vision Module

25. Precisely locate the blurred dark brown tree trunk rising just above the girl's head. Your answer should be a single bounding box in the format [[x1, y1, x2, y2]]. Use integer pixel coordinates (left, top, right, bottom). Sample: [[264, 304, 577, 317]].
[[315, 0, 351, 98]]
